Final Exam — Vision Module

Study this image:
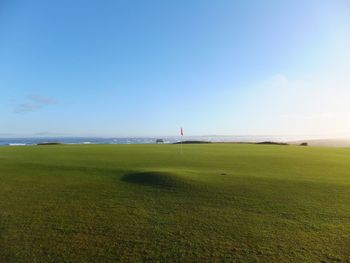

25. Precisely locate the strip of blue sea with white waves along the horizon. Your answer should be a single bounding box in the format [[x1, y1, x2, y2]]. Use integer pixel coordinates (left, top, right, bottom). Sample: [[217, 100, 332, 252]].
[[0, 136, 314, 146]]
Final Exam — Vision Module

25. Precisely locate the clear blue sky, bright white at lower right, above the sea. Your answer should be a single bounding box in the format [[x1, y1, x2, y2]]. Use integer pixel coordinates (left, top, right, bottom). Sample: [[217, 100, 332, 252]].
[[0, 0, 350, 137]]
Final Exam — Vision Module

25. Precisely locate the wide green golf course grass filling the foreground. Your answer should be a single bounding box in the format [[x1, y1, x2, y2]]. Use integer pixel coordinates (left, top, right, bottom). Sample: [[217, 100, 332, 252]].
[[0, 144, 350, 262]]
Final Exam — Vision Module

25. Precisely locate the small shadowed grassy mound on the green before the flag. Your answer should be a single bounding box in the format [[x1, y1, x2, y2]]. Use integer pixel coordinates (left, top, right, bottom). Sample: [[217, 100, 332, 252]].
[[122, 171, 186, 188]]
